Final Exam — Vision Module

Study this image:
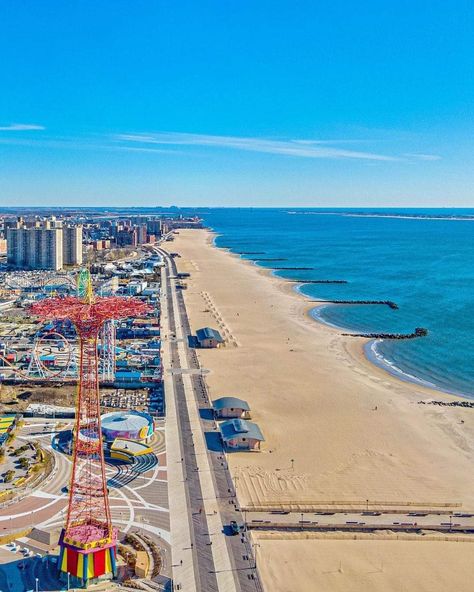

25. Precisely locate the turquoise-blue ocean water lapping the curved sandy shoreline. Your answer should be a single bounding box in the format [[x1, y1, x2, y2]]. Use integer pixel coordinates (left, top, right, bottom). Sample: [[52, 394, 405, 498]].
[[193, 209, 474, 397]]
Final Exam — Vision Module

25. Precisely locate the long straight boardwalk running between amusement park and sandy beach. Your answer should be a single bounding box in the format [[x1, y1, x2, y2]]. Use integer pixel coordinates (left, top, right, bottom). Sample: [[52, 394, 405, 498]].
[[160, 251, 262, 592]]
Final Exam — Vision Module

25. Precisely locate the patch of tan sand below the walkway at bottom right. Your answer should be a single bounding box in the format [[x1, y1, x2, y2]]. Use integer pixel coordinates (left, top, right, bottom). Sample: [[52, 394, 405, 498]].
[[254, 539, 474, 592]]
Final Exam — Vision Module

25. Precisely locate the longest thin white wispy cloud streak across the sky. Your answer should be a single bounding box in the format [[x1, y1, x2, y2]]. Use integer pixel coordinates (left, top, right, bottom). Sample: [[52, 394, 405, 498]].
[[113, 132, 400, 161]]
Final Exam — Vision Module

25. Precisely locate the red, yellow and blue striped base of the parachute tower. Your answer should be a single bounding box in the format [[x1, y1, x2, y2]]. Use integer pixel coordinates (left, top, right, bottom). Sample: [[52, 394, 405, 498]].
[[58, 530, 117, 587]]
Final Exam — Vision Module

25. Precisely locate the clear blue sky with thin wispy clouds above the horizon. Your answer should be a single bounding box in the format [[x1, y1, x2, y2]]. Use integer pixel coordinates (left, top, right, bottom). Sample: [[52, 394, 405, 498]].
[[0, 0, 474, 206]]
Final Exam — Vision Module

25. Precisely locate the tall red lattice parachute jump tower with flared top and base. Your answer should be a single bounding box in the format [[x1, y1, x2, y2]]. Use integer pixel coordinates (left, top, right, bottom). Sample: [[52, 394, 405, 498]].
[[31, 280, 148, 587]]
